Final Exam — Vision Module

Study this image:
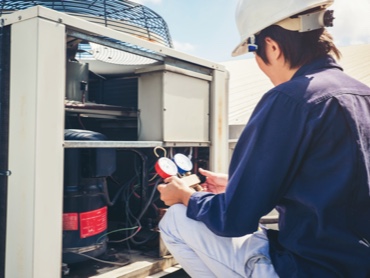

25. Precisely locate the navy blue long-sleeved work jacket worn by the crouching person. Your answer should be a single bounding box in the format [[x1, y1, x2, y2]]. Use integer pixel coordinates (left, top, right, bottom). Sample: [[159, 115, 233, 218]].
[[187, 56, 370, 278]]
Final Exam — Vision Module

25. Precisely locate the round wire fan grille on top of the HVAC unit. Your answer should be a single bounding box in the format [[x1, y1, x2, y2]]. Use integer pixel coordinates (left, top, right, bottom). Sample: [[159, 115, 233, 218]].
[[0, 0, 173, 47]]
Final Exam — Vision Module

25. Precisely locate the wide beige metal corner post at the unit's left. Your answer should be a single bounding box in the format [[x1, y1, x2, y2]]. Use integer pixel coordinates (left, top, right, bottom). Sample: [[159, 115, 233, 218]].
[[5, 17, 65, 278]]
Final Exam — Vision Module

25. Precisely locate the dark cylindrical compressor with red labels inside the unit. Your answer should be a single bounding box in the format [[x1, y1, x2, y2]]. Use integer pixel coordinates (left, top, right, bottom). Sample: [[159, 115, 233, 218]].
[[63, 129, 116, 264]]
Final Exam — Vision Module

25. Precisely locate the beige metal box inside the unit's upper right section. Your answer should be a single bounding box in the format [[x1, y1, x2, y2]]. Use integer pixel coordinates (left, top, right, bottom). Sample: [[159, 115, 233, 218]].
[[139, 66, 211, 143]]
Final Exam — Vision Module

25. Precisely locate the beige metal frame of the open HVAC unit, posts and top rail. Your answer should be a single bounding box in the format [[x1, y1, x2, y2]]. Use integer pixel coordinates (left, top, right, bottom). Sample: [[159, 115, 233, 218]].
[[0, 6, 229, 278]]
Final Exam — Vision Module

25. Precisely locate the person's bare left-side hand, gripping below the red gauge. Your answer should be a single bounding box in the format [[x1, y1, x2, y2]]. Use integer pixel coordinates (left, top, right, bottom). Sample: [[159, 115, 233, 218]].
[[157, 176, 195, 206]]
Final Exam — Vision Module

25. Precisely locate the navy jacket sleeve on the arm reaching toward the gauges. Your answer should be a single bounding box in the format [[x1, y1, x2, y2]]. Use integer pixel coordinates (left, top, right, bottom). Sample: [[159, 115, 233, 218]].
[[187, 91, 310, 237]]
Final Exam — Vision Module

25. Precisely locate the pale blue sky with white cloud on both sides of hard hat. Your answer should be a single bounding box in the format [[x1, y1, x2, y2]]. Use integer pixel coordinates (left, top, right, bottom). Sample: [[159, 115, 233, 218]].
[[131, 0, 370, 62]]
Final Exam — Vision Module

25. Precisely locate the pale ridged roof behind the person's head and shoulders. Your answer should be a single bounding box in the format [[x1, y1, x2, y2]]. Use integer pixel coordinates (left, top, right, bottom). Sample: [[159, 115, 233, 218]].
[[221, 44, 370, 125]]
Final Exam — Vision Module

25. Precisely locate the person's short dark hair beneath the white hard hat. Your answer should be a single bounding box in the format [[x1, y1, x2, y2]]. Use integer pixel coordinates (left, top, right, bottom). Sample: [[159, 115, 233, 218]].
[[256, 25, 341, 69]]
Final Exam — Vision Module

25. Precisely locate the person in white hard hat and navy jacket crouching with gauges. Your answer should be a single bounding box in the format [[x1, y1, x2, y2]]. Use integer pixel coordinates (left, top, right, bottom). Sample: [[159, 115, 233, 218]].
[[158, 0, 370, 278]]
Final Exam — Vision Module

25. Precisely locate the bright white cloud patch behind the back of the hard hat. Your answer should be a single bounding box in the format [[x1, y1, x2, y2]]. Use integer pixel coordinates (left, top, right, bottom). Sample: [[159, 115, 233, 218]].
[[329, 0, 370, 46]]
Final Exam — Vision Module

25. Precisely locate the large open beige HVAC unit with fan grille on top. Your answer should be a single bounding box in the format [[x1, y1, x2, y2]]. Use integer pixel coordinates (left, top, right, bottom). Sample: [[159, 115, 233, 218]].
[[0, 0, 228, 278]]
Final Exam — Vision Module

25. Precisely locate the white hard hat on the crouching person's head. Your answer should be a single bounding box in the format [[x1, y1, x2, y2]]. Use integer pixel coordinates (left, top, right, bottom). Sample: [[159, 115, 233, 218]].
[[232, 0, 334, 56]]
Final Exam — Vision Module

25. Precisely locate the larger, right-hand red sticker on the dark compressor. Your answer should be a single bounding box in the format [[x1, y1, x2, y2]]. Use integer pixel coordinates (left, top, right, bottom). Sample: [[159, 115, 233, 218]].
[[80, 207, 107, 238]]
